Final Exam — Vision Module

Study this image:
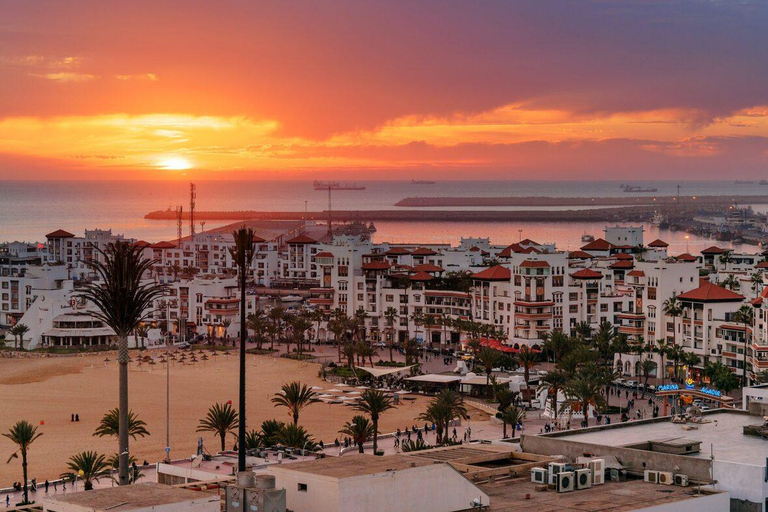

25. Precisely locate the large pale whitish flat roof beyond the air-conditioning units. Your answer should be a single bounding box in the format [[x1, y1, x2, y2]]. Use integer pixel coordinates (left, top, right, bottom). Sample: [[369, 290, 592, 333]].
[[553, 411, 768, 466]]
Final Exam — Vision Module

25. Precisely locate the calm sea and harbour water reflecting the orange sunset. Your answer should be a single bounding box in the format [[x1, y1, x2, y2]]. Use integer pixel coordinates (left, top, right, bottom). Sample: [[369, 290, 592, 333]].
[[0, 181, 756, 253]]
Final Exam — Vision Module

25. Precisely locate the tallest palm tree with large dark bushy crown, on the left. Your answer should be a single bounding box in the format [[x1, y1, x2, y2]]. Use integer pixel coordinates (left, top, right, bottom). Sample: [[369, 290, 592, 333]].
[[80, 240, 165, 485]]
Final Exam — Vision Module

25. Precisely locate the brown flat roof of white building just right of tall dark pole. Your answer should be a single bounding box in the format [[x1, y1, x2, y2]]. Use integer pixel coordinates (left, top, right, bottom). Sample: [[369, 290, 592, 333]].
[[270, 454, 434, 478]]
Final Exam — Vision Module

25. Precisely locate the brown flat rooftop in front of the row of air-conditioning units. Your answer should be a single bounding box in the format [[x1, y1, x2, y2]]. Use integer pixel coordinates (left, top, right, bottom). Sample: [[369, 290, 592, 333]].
[[478, 478, 724, 512]]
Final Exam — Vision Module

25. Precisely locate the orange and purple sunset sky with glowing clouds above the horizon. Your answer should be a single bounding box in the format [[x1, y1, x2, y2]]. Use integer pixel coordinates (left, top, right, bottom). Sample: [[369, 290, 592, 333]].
[[0, 0, 768, 180]]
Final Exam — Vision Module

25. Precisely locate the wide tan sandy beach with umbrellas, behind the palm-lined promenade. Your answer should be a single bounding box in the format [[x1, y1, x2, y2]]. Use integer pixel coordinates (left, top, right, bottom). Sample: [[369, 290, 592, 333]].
[[0, 352, 426, 486]]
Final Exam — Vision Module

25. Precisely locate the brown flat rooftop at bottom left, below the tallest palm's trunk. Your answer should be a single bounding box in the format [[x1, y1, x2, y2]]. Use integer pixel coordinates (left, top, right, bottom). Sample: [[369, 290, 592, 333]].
[[46, 482, 221, 511]]
